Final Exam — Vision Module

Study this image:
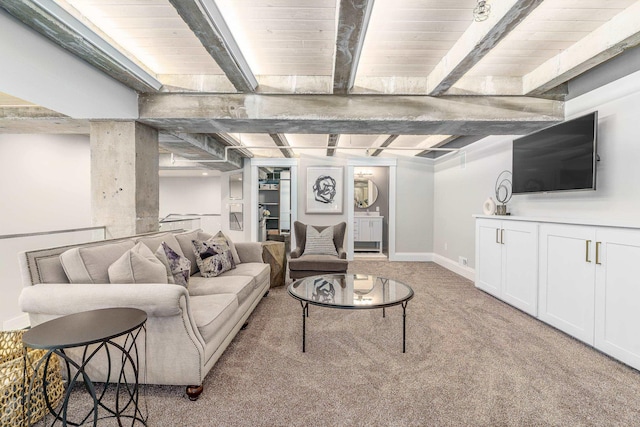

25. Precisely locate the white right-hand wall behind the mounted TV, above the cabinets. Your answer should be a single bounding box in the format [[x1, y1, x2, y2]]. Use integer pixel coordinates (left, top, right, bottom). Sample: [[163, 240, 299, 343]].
[[434, 72, 640, 267]]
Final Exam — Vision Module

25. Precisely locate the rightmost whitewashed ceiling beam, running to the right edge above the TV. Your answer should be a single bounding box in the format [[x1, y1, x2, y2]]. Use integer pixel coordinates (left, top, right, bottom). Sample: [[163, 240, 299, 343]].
[[523, 2, 640, 95]]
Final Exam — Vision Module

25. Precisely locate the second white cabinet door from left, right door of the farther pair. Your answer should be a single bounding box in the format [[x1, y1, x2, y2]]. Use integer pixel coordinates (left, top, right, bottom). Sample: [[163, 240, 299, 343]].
[[500, 221, 538, 316]]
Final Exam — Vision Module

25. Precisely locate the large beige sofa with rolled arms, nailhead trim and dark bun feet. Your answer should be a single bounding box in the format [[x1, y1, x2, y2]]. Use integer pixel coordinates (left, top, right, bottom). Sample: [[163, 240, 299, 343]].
[[19, 230, 270, 400]]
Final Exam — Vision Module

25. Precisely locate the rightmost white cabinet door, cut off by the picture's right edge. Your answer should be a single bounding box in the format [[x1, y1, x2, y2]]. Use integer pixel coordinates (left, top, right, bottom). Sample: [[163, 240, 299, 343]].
[[595, 229, 640, 369]]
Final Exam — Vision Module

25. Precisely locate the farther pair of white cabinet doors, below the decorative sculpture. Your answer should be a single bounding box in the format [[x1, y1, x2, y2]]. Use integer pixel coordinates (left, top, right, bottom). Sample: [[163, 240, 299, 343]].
[[476, 219, 538, 316]]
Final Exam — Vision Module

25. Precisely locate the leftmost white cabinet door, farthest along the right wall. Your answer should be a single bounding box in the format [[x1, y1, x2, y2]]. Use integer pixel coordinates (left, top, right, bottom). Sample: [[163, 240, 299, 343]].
[[476, 219, 502, 298]]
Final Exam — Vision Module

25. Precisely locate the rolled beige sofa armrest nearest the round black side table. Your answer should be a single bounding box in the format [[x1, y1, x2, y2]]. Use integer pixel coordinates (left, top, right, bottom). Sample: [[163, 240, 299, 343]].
[[19, 283, 189, 317]]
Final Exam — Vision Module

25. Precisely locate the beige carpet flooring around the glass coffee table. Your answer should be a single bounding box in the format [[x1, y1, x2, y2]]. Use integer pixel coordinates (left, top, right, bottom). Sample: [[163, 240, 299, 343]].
[[50, 261, 640, 426]]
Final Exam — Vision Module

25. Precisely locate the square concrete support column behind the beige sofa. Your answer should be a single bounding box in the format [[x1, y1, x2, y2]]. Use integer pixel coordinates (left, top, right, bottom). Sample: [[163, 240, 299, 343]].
[[90, 121, 159, 238]]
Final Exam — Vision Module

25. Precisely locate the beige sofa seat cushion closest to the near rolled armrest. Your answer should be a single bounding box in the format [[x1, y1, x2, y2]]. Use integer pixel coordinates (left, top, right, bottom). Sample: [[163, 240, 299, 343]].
[[189, 294, 238, 342]]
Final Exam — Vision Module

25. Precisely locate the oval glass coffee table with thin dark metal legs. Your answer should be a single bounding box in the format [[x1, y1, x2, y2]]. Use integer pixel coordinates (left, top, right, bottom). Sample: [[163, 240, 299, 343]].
[[288, 274, 413, 353]]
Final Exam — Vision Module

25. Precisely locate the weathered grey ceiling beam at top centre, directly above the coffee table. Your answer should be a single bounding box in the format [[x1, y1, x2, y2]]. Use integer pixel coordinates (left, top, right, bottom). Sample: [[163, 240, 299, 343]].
[[333, 0, 374, 95]]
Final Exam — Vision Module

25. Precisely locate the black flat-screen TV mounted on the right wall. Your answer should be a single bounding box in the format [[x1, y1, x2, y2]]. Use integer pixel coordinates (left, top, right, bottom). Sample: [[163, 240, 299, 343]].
[[512, 111, 598, 194]]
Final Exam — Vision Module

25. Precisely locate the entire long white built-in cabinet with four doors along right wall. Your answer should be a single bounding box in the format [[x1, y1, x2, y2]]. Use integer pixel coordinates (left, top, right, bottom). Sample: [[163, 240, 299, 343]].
[[476, 218, 640, 369]]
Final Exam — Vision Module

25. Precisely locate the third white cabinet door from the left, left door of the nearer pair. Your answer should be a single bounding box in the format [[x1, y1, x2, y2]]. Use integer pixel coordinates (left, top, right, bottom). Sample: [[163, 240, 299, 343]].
[[538, 224, 595, 345]]
